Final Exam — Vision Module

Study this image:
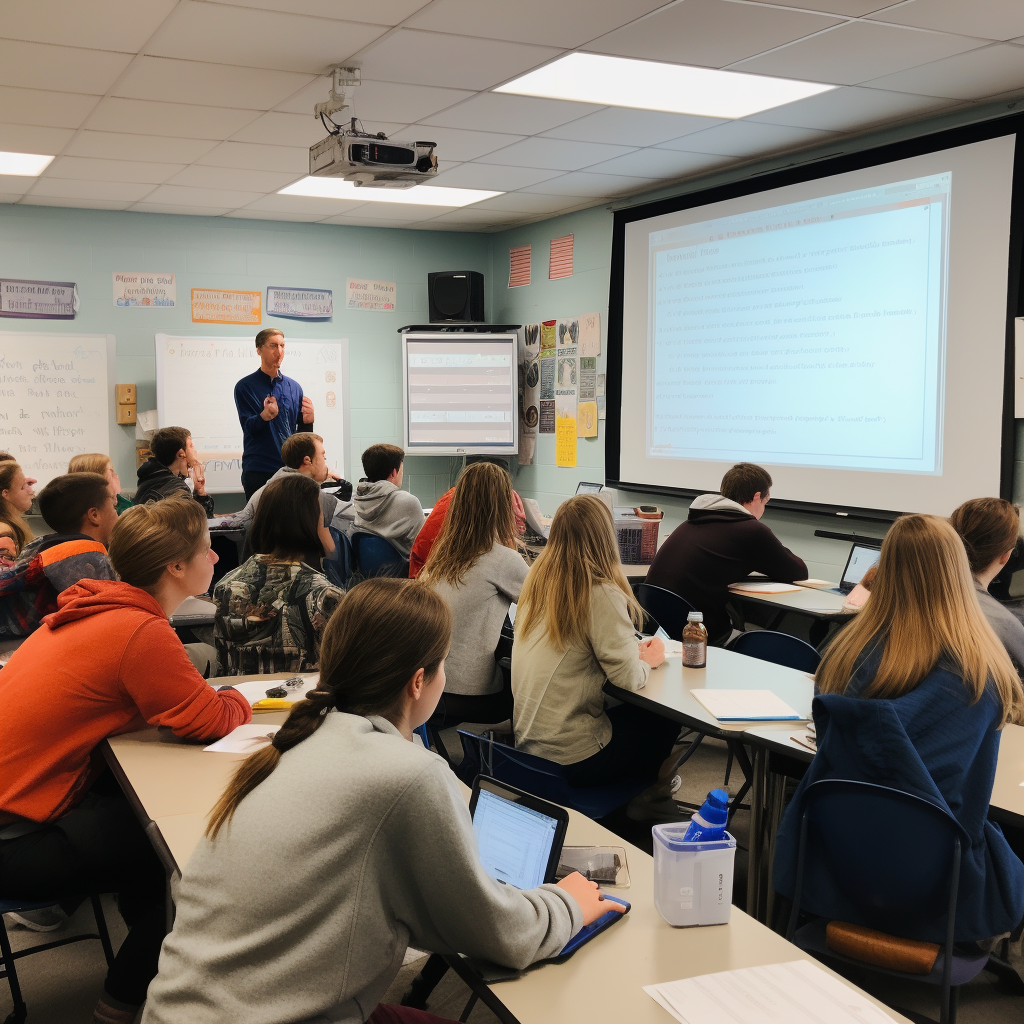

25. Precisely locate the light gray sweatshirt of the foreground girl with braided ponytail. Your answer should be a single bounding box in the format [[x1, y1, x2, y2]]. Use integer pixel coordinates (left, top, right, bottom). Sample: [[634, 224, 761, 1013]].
[[142, 712, 583, 1024]]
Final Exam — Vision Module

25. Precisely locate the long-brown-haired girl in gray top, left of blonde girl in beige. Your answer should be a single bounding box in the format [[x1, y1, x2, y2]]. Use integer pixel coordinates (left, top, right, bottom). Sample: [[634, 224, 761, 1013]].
[[422, 462, 527, 728]]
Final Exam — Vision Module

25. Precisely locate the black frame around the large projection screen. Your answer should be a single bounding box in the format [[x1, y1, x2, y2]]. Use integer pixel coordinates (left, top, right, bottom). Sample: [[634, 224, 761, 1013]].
[[604, 114, 1024, 522]]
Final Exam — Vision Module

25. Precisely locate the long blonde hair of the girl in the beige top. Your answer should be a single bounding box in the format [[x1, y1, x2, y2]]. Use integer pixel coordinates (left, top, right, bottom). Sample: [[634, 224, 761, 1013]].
[[515, 495, 643, 650]]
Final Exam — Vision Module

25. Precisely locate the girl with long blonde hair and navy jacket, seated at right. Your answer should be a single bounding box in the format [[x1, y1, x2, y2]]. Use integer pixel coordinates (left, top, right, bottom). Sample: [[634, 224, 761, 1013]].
[[774, 515, 1024, 943]]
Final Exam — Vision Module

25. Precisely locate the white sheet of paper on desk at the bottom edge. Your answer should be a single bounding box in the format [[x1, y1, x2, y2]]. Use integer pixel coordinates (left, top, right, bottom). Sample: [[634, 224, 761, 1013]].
[[644, 961, 892, 1024]]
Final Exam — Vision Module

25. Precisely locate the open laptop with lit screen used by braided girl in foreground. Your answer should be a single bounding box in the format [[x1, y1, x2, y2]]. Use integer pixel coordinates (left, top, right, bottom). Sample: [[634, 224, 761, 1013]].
[[469, 775, 630, 964]]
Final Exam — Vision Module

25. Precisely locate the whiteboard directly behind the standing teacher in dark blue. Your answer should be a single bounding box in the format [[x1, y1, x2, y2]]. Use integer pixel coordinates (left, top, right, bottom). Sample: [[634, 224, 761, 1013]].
[[156, 334, 348, 494]]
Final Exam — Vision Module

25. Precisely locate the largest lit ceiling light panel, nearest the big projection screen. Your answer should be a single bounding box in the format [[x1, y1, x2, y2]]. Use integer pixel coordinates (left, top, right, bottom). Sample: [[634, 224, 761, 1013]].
[[494, 53, 837, 118]]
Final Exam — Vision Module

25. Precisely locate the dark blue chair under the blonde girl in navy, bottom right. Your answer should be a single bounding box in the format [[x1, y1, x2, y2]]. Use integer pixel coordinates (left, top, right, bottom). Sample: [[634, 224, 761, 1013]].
[[786, 779, 988, 1024]]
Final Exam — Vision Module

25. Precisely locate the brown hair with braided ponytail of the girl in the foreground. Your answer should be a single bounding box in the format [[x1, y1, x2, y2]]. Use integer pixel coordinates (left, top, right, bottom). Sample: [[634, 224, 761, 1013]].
[[205, 581, 452, 840]]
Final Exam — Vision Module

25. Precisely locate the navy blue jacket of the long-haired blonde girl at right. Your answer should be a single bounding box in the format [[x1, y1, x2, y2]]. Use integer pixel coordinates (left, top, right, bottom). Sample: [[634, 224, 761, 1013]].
[[773, 655, 1024, 942]]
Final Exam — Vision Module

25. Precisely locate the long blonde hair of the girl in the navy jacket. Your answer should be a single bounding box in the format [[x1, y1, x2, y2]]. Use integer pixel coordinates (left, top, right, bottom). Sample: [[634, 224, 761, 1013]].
[[814, 515, 1024, 722]]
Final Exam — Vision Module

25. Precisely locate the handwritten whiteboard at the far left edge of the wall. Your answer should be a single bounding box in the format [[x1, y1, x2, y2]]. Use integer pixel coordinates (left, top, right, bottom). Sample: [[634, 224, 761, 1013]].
[[0, 331, 116, 489]]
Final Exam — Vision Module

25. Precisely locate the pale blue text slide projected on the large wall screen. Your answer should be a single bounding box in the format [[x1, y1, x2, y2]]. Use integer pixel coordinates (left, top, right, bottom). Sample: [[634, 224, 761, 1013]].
[[646, 173, 952, 475]]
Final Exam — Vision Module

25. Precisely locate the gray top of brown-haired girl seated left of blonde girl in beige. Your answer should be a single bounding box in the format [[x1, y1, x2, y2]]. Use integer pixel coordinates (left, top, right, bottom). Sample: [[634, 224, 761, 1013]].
[[424, 543, 529, 696]]
